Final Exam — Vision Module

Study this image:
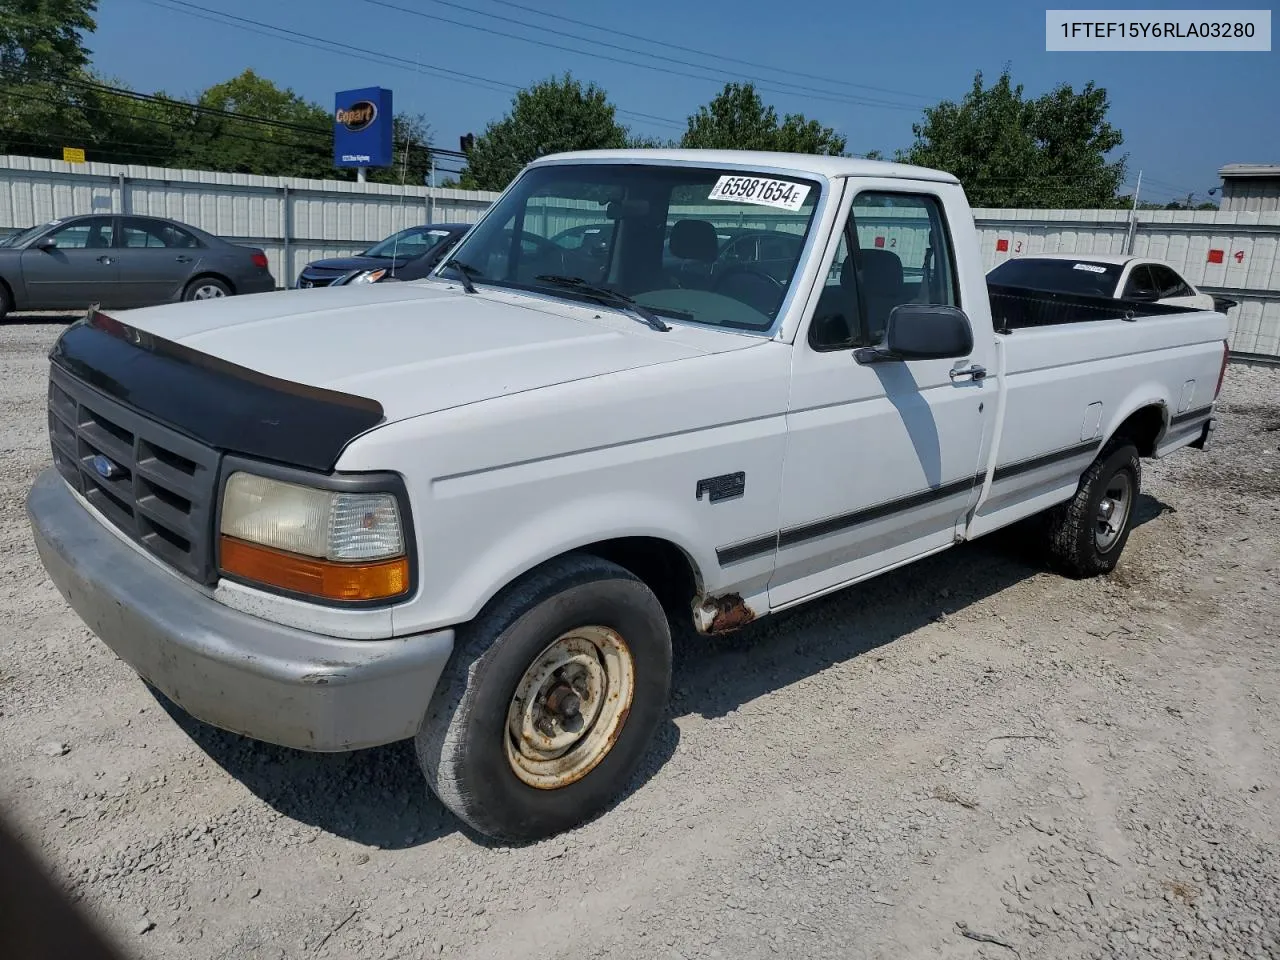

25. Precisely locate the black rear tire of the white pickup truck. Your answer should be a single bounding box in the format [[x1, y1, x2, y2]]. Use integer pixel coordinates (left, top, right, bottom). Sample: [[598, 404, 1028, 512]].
[[1047, 439, 1142, 579]]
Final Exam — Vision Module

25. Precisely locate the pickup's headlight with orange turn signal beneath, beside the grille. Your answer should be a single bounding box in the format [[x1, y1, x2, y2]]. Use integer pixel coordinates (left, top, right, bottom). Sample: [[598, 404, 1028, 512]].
[[219, 471, 410, 600]]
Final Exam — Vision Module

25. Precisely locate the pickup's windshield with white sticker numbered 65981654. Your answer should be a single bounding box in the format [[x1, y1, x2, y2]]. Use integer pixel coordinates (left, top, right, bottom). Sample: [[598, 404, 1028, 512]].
[[442, 164, 820, 330]]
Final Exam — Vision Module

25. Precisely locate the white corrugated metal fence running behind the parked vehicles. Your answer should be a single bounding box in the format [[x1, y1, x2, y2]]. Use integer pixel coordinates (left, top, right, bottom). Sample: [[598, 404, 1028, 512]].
[[0, 156, 1280, 357]]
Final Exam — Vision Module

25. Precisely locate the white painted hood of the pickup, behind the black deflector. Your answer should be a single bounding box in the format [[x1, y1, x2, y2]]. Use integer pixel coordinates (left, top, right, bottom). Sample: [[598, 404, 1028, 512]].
[[115, 282, 762, 421]]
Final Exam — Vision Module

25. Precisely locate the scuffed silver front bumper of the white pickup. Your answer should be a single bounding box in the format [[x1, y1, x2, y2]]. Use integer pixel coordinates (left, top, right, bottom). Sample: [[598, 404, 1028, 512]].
[[27, 468, 453, 751]]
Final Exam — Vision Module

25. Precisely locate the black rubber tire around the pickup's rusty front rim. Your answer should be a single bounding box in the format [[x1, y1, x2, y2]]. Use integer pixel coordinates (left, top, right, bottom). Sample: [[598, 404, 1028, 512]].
[[416, 554, 671, 842]]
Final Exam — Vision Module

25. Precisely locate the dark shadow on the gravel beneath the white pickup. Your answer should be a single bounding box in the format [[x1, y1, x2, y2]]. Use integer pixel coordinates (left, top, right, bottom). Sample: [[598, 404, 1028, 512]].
[[152, 494, 1172, 850]]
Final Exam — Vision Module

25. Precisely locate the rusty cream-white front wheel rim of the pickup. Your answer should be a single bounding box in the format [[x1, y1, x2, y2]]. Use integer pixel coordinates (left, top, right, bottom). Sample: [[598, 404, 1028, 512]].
[[504, 626, 635, 790]]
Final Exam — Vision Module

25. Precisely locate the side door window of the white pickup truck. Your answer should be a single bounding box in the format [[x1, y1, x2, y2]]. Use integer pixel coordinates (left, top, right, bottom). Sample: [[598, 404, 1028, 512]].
[[809, 191, 959, 349]]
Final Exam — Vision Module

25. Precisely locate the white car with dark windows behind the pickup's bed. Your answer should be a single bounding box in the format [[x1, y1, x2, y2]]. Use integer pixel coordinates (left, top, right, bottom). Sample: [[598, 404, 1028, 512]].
[[987, 253, 1217, 310]]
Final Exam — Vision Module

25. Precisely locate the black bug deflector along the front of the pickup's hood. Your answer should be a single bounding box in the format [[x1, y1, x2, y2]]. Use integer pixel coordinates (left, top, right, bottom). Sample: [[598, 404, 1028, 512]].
[[49, 308, 384, 472]]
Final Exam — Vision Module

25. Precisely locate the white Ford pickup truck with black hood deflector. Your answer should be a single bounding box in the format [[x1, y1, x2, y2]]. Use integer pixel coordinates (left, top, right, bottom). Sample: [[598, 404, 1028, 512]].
[[28, 150, 1228, 840]]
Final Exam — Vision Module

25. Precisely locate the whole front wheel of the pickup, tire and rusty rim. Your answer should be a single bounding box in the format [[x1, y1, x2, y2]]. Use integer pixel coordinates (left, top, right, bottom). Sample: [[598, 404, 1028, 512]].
[[417, 554, 671, 841]]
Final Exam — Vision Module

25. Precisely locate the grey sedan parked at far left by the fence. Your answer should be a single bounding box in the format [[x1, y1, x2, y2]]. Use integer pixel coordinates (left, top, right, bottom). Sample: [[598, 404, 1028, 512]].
[[0, 214, 275, 316]]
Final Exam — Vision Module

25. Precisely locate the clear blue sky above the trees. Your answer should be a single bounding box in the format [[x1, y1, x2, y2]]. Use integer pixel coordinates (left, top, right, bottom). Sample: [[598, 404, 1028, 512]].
[[90, 0, 1280, 200]]
